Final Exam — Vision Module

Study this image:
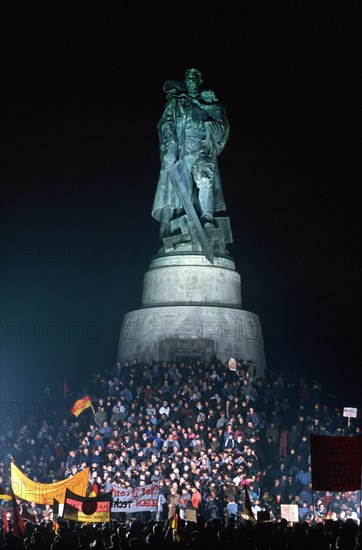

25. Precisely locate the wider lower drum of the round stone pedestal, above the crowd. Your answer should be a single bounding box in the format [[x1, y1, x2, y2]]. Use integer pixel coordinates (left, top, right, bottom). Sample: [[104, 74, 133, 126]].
[[117, 306, 266, 376]]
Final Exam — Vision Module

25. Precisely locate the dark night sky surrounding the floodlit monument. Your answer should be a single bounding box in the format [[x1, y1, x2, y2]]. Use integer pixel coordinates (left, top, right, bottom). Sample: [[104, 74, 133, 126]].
[[1, 1, 361, 406]]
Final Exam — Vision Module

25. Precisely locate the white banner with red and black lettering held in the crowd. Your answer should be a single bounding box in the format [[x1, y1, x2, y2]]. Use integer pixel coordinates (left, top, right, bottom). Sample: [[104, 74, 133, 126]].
[[107, 482, 159, 514]]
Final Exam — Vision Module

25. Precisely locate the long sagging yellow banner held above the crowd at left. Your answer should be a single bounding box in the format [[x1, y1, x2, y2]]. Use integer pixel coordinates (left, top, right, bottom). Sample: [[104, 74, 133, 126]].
[[10, 462, 89, 504]]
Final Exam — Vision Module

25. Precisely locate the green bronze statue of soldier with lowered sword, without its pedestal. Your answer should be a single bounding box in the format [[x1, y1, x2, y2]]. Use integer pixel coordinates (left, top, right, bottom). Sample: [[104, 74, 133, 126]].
[[152, 69, 232, 262]]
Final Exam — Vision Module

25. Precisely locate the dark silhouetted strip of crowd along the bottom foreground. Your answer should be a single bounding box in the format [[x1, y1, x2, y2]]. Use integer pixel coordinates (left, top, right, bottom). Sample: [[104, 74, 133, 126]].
[[1, 518, 361, 550]]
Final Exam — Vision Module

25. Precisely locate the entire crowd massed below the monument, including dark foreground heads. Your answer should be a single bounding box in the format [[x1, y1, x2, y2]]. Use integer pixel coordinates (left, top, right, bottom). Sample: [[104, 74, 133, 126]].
[[0, 358, 360, 550]]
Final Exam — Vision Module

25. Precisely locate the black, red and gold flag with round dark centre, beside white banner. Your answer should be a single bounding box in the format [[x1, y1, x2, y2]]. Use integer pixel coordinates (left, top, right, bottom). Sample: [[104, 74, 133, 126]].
[[63, 489, 112, 523]]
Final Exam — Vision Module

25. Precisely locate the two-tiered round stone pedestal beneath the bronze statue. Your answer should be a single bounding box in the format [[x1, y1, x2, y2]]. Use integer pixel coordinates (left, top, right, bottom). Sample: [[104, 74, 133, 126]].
[[117, 253, 266, 376]]
